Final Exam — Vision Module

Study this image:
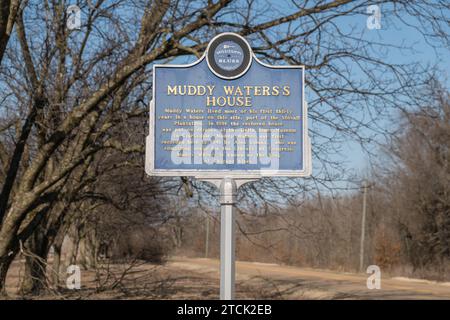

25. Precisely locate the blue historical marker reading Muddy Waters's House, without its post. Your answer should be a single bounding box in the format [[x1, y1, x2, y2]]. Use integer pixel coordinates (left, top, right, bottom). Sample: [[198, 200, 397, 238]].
[[146, 33, 311, 179]]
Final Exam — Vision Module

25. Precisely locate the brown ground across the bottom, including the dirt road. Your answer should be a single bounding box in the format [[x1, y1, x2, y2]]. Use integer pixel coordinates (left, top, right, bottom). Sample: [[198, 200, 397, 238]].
[[3, 257, 450, 299]]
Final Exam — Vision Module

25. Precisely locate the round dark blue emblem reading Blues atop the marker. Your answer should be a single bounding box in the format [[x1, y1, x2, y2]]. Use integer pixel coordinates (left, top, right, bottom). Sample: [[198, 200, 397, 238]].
[[206, 33, 252, 79]]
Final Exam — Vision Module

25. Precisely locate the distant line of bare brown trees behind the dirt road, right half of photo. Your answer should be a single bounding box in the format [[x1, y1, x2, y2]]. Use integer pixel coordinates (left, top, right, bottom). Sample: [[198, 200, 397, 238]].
[[179, 80, 450, 281]]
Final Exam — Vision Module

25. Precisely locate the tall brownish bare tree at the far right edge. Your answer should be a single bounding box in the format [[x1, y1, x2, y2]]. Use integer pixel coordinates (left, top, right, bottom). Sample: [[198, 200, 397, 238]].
[[380, 80, 450, 269]]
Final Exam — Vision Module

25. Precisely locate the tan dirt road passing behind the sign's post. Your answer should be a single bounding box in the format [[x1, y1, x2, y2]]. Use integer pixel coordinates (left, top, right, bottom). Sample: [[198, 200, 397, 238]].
[[168, 257, 450, 299]]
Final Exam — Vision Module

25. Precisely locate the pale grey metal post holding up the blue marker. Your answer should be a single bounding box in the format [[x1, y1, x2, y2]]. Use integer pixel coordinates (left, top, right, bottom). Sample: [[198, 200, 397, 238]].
[[220, 178, 237, 300]]
